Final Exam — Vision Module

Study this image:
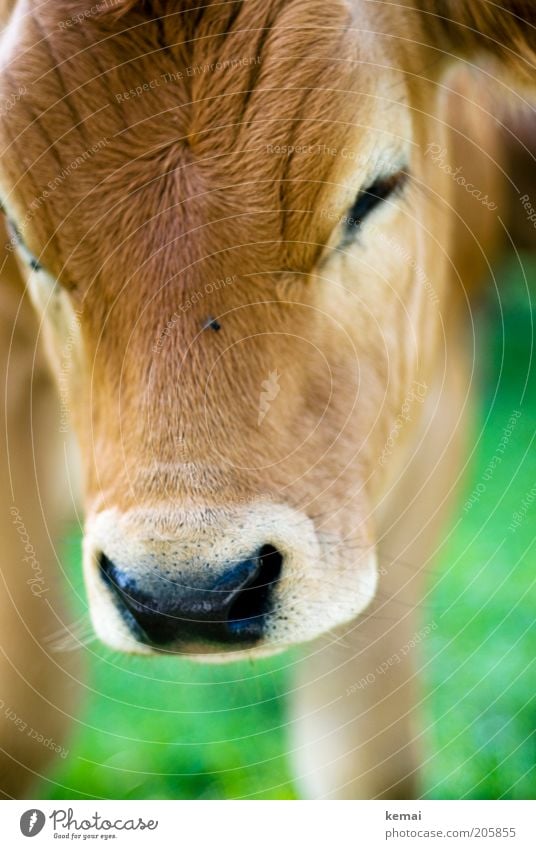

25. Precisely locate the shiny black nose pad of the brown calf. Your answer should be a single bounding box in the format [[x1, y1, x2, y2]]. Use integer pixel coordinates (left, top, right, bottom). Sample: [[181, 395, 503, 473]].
[[99, 545, 283, 646]]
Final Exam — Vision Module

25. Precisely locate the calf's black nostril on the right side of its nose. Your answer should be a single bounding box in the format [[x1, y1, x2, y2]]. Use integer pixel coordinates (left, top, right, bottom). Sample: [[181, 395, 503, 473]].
[[227, 545, 283, 638]]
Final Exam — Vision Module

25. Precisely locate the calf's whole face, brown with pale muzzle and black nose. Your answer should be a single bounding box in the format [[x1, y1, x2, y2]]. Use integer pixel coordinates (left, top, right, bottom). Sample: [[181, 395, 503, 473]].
[[0, 0, 528, 654]]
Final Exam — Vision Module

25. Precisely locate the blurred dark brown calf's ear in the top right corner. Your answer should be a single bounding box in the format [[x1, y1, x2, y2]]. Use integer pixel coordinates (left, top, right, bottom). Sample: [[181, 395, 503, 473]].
[[416, 0, 536, 90]]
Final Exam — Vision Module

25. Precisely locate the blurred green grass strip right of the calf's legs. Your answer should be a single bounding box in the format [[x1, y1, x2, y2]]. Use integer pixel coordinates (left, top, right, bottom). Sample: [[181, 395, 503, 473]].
[[425, 255, 536, 799]]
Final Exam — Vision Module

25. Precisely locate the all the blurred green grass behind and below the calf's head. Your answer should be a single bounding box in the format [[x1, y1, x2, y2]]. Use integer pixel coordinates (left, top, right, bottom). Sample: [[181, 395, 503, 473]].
[[36, 259, 536, 799]]
